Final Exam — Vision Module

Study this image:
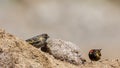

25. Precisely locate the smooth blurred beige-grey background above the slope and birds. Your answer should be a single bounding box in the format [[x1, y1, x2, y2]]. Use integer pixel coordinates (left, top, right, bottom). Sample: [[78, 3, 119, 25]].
[[0, 0, 120, 58]]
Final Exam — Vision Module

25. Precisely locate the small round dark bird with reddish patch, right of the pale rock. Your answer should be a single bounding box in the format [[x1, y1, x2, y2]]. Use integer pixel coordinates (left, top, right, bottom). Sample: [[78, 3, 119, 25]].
[[88, 49, 101, 62]]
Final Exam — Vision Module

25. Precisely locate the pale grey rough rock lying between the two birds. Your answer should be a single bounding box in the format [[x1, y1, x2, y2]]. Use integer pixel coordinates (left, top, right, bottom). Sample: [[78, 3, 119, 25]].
[[47, 39, 82, 64]]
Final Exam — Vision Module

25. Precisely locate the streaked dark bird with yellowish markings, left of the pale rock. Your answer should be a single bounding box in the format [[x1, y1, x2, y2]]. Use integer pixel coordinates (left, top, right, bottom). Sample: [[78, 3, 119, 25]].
[[26, 34, 49, 48]]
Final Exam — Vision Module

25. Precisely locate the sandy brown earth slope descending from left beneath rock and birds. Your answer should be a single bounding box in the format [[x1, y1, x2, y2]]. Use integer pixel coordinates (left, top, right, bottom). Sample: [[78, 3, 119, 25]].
[[0, 29, 120, 68]]
